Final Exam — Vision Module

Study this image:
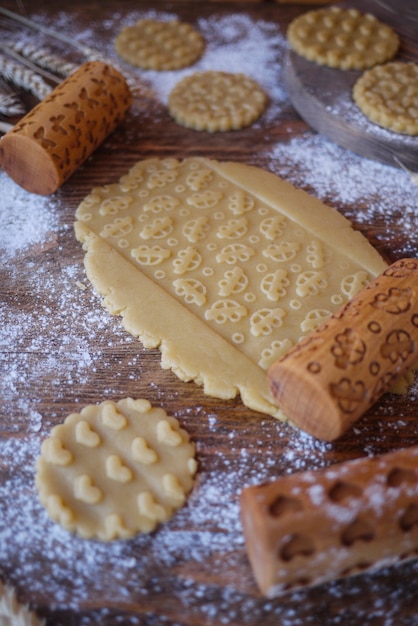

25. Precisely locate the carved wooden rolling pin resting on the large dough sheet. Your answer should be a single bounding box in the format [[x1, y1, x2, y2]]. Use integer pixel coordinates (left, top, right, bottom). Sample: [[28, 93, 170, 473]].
[[268, 259, 418, 441]]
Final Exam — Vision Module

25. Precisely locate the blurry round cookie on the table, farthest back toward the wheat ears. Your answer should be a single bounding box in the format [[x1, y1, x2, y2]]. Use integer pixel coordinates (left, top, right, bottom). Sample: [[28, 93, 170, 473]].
[[115, 19, 205, 70]]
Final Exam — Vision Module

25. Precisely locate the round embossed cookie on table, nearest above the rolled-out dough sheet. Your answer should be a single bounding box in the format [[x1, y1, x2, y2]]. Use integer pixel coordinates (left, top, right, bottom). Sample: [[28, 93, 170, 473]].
[[168, 71, 267, 132]]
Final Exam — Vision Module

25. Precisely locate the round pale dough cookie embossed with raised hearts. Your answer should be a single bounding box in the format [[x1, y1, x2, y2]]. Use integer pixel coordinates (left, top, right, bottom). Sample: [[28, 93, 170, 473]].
[[36, 398, 197, 541]]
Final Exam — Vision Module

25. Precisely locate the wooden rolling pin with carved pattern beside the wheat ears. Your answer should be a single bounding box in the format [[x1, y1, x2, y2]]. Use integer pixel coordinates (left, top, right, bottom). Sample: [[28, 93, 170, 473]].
[[0, 61, 132, 195]]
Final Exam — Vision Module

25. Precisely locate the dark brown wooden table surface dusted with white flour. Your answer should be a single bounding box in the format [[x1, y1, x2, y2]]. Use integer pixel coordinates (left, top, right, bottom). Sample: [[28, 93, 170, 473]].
[[0, 0, 418, 626]]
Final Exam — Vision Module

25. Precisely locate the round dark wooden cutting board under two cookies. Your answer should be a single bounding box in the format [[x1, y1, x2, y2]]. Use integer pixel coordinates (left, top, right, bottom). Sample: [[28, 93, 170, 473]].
[[284, 0, 418, 172]]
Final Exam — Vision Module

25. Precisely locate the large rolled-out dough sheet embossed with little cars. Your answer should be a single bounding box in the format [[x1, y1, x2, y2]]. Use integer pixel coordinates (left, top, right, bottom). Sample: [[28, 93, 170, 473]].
[[75, 158, 387, 419]]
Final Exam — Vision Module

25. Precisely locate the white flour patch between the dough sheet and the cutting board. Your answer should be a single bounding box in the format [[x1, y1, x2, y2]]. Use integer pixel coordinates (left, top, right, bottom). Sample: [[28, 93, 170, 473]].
[[266, 132, 418, 258]]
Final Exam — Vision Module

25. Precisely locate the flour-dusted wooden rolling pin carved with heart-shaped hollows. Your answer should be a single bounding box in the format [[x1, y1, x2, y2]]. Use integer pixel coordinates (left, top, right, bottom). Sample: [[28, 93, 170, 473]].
[[240, 446, 418, 597]]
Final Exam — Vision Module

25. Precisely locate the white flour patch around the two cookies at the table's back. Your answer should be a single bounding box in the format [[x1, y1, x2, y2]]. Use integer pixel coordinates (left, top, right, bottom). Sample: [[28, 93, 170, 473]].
[[21, 9, 289, 121]]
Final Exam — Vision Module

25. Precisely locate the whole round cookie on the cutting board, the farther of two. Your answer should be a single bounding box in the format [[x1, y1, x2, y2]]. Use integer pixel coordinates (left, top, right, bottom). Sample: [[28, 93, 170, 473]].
[[287, 7, 399, 70]]
